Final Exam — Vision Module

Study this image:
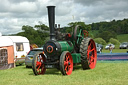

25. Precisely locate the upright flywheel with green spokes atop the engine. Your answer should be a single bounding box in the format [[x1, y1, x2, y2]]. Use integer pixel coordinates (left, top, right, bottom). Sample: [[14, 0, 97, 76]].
[[74, 25, 84, 52]]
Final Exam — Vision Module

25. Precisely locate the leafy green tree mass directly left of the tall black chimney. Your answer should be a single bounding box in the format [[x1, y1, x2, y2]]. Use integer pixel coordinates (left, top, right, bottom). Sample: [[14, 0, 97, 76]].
[[17, 25, 49, 46]]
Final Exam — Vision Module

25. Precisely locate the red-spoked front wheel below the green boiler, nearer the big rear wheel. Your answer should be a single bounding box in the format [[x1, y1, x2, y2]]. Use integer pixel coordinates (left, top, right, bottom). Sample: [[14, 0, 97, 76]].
[[60, 51, 73, 75]]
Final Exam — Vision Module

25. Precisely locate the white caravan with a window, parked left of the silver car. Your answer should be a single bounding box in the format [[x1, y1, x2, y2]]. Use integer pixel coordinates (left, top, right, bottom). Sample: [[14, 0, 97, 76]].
[[0, 36, 30, 65]]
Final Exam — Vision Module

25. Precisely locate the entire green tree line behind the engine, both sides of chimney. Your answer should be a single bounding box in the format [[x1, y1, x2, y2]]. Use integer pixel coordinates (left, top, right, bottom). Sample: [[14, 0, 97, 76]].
[[10, 19, 128, 46]]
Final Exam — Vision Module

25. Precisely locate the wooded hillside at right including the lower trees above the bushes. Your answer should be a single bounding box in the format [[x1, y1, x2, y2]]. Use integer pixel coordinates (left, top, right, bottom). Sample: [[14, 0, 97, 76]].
[[91, 19, 128, 42]]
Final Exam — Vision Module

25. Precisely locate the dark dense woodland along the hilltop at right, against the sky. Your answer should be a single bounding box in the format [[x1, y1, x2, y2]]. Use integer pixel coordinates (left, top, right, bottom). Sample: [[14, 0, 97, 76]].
[[91, 19, 128, 34]]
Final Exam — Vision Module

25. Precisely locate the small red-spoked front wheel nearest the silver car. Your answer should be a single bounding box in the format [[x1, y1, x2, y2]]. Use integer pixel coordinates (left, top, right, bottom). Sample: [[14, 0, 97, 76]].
[[32, 53, 46, 75]]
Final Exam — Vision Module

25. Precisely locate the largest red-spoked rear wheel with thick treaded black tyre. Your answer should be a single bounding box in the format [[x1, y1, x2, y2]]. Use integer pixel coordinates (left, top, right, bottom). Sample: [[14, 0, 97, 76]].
[[80, 38, 97, 70]]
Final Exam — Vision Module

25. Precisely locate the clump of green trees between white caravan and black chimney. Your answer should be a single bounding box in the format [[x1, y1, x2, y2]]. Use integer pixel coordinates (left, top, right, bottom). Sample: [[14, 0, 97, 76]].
[[15, 24, 49, 47]]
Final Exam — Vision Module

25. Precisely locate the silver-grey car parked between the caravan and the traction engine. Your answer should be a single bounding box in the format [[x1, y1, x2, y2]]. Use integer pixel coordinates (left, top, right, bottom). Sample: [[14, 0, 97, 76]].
[[25, 48, 43, 68]]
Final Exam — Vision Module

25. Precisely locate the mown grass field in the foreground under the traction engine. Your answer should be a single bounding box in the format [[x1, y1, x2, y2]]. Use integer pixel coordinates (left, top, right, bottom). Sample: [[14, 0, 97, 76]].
[[0, 61, 128, 85]]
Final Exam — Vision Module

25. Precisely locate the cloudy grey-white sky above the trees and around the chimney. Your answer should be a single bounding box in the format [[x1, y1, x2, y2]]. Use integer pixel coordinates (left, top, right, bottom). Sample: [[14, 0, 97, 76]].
[[0, 0, 128, 35]]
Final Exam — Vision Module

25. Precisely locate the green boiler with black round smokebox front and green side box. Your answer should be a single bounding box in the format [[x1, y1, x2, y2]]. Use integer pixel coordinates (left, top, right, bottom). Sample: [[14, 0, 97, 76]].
[[44, 40, 81, 63]]
